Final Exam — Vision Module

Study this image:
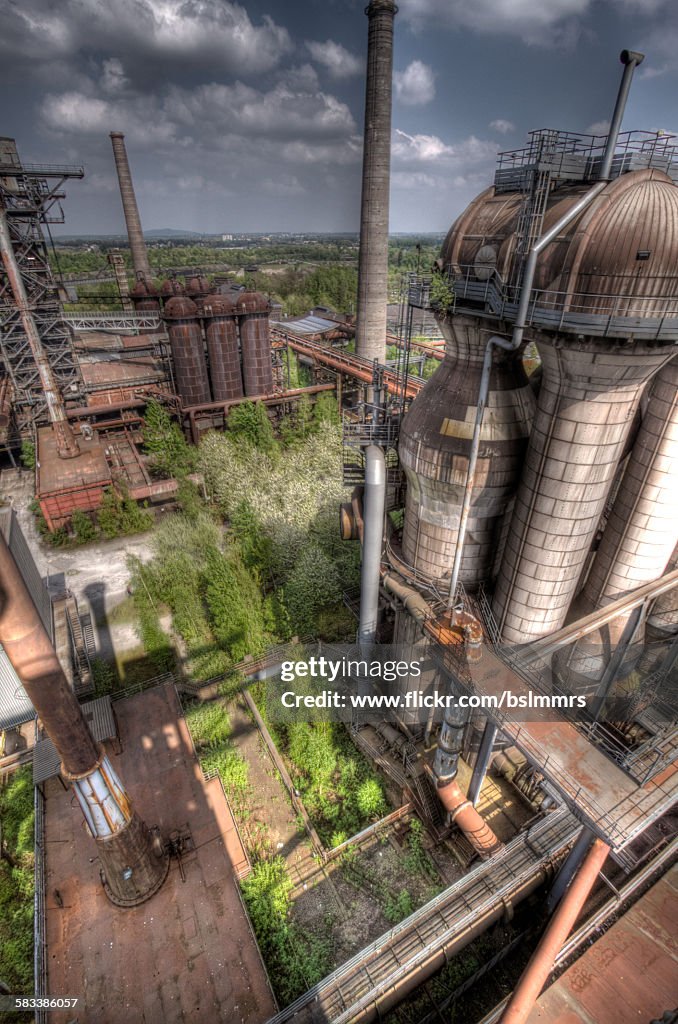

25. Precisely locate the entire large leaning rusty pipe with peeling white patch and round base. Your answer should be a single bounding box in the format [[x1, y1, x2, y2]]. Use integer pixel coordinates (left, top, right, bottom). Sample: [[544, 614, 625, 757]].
[[0, 534, 169, 906]]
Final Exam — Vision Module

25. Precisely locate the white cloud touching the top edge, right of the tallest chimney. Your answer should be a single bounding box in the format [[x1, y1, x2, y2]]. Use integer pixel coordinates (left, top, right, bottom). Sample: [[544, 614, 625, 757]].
[[400, 0, 592, 45]]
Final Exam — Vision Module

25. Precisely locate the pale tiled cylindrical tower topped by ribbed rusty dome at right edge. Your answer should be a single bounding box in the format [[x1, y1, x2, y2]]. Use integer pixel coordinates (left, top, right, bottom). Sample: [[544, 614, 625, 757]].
[[493, 170, 678, 643]]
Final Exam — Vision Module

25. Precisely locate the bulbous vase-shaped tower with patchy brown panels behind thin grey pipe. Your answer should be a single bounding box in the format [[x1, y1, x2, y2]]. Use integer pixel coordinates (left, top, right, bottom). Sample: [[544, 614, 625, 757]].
[[398, 316, 535, 590]]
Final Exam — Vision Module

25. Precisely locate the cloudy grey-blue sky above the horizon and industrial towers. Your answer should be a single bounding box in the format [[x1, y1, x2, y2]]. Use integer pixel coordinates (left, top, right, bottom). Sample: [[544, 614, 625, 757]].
[[0, 0, 678, 233]]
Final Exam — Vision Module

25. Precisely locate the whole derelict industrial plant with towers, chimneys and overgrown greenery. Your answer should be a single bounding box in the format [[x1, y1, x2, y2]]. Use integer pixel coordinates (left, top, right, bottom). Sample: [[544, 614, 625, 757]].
[[0, 6, 678, 1024]]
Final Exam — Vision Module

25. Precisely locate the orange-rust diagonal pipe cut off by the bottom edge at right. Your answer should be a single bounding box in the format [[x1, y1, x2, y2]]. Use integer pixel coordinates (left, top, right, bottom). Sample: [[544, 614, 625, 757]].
[[502, 839, 609, 1024]]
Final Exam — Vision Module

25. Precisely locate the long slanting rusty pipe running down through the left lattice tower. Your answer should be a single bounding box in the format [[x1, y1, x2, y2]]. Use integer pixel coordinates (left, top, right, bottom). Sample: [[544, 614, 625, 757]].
[[0, 204, 80, 459]]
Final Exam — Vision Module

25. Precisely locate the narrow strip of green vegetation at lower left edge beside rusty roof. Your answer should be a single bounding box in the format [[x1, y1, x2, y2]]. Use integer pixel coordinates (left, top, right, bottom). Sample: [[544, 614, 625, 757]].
[[0, 767, 35, 994]]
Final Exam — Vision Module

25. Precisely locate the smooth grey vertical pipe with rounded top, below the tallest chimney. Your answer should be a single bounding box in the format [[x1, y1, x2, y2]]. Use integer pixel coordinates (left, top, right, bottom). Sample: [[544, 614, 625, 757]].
[[357, 444, 386, 643]]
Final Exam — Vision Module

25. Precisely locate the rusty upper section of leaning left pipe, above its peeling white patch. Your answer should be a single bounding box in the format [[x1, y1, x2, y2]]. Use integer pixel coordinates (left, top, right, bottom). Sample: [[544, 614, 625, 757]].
[[0, 534, 99, 776]]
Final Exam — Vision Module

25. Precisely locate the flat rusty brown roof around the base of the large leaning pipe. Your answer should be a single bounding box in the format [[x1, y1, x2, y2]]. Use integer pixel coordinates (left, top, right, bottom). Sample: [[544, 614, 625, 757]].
[[46, 686, 274, 1024]]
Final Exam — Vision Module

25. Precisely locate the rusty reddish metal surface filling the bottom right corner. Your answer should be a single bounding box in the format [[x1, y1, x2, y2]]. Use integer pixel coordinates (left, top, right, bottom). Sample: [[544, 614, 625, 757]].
[[527, 866, 678, 1024]]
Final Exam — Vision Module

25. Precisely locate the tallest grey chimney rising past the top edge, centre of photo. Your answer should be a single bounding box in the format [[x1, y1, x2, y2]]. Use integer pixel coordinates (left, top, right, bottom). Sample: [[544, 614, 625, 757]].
[[355, 0, 397, 362]]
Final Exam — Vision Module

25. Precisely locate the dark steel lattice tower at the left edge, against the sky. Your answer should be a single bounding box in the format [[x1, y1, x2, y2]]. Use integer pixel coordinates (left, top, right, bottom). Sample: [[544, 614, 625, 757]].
[[0, 138, 84, 432]]
